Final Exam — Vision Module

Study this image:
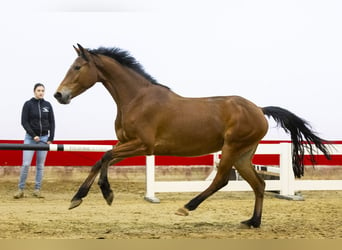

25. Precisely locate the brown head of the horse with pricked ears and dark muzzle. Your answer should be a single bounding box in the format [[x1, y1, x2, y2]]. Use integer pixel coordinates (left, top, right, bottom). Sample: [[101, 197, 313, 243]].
[[54, 44, 98, 104]]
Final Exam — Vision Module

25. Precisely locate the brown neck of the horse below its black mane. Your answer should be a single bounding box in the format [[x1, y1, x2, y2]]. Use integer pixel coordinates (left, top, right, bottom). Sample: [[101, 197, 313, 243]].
[[101, 60, 150, 106]]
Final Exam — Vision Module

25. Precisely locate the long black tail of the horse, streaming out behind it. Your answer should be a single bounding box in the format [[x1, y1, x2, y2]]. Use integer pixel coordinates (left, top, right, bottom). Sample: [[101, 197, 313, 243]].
[[262, 107, 330, 178]]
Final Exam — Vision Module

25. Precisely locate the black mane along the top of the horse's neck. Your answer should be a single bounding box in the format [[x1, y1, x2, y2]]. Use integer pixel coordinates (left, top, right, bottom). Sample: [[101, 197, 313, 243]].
[[87, 47, 168, 88]]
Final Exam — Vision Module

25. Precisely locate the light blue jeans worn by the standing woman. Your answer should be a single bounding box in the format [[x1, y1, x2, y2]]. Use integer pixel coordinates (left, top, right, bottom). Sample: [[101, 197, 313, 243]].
[[18, 134, 49, 189]]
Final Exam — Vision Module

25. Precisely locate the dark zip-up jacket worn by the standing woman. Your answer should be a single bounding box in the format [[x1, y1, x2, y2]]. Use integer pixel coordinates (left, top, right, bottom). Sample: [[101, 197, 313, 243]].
[[21, 98, 55, 142]]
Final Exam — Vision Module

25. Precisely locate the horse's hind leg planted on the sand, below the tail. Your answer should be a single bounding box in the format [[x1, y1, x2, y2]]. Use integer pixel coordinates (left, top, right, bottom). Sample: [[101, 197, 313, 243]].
[[234, 146, 265, 228]]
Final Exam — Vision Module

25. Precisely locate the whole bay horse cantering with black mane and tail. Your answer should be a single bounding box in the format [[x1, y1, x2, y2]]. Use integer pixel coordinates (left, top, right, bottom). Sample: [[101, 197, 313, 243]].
[[54, 44, 330, 228]]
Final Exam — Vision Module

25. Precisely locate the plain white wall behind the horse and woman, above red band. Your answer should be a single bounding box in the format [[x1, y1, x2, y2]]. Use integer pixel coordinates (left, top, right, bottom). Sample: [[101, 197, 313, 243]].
[[0, 0, 342, 140]]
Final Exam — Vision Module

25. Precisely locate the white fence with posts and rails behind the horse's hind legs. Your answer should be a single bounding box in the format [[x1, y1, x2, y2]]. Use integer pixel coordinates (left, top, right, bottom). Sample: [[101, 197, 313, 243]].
[[145, 143, 342, 202]]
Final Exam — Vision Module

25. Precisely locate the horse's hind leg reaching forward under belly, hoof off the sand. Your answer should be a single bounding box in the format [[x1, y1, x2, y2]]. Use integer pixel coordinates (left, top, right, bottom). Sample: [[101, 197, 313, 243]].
[[176, 146, 235, 216]]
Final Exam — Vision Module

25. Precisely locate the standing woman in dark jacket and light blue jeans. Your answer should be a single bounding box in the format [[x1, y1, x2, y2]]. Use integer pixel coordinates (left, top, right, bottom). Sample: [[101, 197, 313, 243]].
[[14, 83, 55, 199]]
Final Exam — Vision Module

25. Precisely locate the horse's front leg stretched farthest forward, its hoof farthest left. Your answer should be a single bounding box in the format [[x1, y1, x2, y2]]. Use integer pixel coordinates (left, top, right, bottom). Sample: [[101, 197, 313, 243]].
[[69, 150, 114, 209]]
